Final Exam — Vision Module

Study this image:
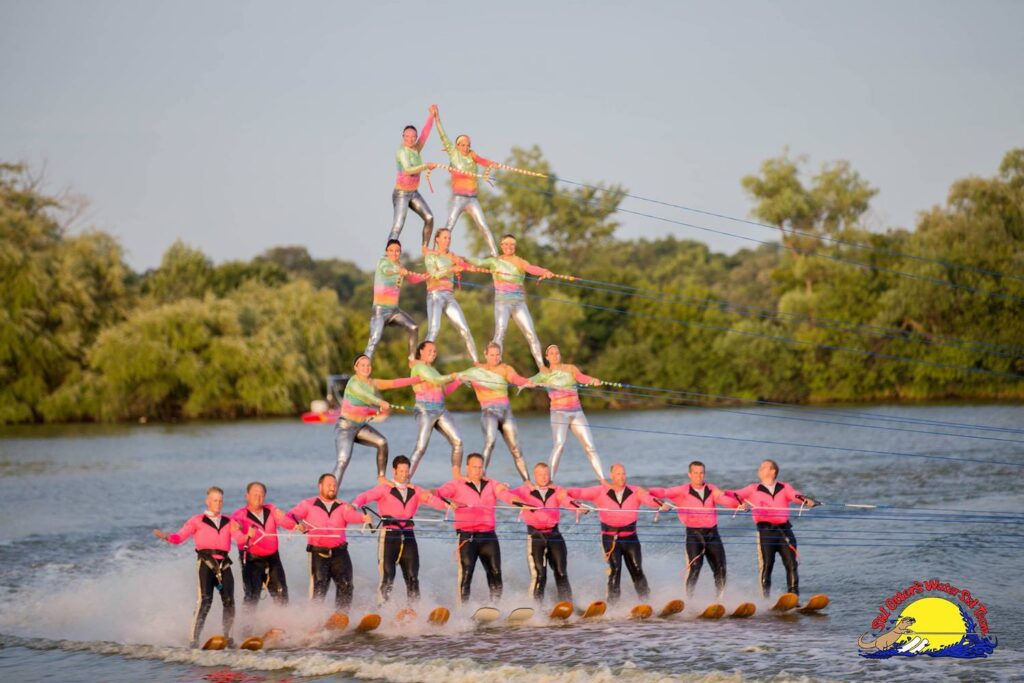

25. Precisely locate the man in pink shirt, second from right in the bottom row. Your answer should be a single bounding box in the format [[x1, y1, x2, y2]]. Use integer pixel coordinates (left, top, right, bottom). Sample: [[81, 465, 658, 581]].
[[650, 460, 739, 600]]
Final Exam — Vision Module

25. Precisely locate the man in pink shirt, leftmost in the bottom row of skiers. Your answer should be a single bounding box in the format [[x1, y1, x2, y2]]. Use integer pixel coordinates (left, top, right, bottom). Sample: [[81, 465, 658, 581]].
[[153, 486, 246, 647]]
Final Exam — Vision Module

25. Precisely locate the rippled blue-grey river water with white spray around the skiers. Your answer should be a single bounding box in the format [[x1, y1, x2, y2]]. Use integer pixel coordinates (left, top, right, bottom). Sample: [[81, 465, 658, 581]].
[[0, 405, 1024, 683]]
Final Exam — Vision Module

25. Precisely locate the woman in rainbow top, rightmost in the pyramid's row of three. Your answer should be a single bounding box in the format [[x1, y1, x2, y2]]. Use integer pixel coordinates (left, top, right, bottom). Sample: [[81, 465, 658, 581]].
[[466, 234, 555, 372]]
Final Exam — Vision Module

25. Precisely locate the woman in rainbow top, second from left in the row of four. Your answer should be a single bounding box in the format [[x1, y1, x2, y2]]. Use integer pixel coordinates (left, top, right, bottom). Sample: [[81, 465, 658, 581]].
[[409, 341, 462, 479]]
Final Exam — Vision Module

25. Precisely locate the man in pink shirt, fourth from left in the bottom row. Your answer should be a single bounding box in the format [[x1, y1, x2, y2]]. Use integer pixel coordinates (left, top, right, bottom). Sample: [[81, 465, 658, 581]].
[[352, 456, 447, 603]]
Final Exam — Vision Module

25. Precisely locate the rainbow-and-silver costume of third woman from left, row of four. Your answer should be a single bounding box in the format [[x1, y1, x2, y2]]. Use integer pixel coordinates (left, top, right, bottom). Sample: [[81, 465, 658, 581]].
[[456, 362, 529, 481]]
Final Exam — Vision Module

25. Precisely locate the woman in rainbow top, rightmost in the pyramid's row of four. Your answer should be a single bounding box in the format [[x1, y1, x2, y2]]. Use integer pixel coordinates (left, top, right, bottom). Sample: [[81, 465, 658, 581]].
[[529, 344, 605, 482]]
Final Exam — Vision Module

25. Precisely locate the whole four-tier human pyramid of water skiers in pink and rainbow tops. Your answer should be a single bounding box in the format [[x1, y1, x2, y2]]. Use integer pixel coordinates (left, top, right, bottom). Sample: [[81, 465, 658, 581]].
[[154, 105, 817, 646]]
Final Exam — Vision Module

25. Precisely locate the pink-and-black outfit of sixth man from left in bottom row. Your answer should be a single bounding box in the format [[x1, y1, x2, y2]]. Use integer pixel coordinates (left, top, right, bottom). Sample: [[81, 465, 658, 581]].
[[511, 483, 577, 602]]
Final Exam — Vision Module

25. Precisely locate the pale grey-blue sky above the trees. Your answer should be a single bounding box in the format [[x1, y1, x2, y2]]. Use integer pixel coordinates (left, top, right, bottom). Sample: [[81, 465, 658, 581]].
[[0, 0, 1024, 270]]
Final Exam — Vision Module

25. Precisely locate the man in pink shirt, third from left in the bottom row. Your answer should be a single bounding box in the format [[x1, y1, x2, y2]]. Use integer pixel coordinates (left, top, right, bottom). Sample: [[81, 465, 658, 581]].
[[288, 473, 370, 609]]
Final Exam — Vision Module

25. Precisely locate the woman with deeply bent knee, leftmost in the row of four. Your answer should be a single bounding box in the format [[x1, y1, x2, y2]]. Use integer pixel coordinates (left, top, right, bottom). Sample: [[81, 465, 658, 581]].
[[334, 353, 423, 485]]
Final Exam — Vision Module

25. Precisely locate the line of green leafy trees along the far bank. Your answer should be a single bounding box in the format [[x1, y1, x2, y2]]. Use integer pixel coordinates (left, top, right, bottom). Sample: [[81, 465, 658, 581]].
[[0, 146, 1024, 423]]
